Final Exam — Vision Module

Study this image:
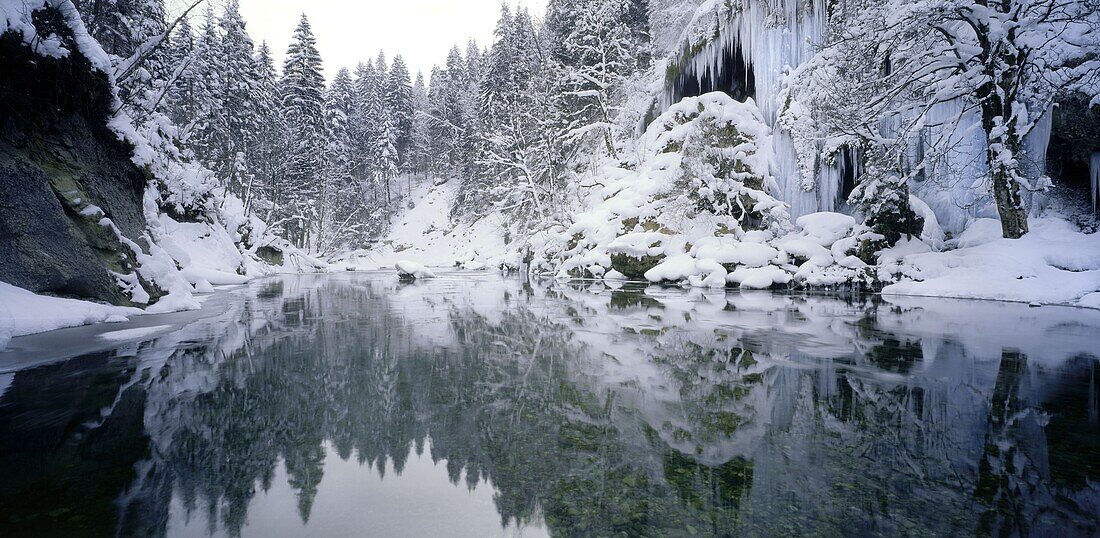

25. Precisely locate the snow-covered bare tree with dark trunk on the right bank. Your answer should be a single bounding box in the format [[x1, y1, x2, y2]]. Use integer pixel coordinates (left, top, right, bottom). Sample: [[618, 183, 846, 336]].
[[792, 0, 1100, 238]]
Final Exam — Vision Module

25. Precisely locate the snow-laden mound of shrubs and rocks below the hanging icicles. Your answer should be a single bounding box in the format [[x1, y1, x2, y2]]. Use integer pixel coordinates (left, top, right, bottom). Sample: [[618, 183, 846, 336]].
[[536, 92, 791, 282]]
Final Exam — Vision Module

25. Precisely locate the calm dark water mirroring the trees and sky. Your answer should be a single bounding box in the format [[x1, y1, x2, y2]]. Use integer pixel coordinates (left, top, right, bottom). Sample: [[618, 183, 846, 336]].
[[0, 274, 1100, 537]]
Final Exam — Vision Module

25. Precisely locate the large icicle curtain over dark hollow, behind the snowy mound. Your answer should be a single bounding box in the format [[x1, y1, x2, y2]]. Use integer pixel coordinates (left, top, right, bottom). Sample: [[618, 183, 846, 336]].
[[661, 0, 840, 217]]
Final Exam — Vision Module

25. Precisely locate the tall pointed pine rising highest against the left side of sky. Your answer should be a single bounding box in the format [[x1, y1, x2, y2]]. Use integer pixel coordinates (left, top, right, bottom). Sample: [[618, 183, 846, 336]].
[[279, 14, 325, 248]]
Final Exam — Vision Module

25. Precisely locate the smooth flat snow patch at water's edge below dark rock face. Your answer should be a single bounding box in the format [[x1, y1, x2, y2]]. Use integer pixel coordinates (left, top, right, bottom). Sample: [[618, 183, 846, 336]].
[[0, 277, 143, 349]]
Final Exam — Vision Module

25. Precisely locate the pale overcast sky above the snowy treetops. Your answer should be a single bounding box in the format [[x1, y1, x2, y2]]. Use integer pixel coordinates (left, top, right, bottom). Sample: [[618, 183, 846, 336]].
[[237, 0, 547, 80]]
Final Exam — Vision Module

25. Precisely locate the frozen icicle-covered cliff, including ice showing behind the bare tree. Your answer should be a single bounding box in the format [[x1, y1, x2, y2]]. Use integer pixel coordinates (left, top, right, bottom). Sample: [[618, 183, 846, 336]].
[[658, 0, 1051, 233]]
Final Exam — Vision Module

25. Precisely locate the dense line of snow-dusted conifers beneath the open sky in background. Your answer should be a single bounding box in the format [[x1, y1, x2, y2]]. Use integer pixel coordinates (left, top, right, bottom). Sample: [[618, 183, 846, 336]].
[[77, 0, 651, 254]]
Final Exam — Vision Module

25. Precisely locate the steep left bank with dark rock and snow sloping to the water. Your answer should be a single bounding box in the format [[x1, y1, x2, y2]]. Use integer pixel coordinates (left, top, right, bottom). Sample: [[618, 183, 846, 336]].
[[0, 0, 323, 348]]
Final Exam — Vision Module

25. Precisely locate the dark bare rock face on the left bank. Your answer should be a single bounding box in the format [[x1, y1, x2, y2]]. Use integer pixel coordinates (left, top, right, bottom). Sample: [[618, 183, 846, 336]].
[[0, 23, 150, 305]]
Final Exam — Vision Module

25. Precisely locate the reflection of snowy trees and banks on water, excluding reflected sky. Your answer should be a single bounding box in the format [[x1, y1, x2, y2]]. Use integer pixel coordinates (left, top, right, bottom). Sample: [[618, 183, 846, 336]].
[[0, 277, 1100, 536]]
